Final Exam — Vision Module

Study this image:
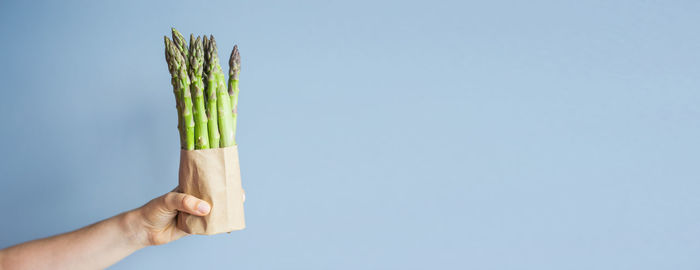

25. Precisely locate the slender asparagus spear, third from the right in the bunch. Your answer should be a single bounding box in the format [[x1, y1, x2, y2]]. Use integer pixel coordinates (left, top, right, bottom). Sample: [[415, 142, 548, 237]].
[[203, 36, 221, 148]]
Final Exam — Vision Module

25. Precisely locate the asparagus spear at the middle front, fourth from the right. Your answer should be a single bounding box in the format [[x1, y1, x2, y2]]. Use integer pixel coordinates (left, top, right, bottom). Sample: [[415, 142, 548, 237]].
[[189, 35, 209, 149]]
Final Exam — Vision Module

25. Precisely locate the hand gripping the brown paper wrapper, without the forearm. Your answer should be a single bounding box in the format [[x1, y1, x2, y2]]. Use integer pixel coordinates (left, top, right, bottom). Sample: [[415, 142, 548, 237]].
[[131, 192, 211, 245]]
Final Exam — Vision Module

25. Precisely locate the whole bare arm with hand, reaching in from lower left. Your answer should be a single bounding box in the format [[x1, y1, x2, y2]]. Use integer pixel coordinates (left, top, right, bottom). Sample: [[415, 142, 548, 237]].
[[0, 192, 211, 270]]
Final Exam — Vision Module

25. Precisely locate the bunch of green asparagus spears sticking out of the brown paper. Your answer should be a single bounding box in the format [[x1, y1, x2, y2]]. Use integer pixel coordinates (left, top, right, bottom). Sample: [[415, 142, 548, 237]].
[[165, 28, 241, 150]]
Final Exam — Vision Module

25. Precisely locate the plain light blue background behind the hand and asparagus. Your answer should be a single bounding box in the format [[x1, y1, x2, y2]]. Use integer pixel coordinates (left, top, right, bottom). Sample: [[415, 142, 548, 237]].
[[0, 1, 700, 270]]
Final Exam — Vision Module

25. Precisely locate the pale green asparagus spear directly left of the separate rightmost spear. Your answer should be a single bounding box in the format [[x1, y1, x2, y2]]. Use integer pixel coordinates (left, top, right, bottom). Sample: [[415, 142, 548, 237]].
[[208, 35, 236, 147]]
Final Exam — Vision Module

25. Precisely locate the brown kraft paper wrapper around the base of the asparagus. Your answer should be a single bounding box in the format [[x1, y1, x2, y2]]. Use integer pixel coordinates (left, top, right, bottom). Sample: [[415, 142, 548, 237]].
[[177, 146, 245, 235]]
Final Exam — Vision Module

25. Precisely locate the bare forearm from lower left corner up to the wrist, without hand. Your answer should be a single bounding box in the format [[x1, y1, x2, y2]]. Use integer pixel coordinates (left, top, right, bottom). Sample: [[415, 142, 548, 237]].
[[0, 211, 147, 269]]
